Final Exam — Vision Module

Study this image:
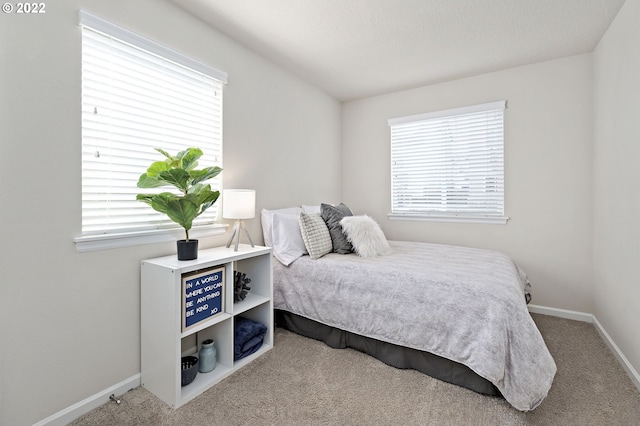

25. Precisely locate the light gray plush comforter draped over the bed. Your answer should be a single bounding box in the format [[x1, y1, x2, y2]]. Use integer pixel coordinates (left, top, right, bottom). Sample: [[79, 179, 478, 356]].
[[273, 241, 556, 411]]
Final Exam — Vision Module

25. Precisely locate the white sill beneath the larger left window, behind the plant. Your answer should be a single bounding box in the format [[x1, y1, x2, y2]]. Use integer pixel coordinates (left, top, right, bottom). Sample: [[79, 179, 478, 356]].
[[73, 224, 228, 253]]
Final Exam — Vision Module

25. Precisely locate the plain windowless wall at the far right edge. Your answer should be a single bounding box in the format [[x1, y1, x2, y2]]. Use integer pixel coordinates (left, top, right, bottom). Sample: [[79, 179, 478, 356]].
[[593, 0, 640, 382]]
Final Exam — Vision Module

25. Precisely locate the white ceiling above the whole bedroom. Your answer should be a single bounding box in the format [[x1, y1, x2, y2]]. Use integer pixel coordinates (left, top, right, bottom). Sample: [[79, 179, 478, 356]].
[[166, 0, 624, 101]]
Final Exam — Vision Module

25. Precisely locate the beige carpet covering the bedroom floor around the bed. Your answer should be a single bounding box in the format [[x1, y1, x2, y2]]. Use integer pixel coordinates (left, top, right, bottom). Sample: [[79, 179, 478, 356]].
[[72, 314, 640, 426]]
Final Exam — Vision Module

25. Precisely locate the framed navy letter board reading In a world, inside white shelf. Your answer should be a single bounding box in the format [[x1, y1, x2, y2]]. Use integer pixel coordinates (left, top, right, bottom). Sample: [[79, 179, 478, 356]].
[[182, 266, 224, 332]]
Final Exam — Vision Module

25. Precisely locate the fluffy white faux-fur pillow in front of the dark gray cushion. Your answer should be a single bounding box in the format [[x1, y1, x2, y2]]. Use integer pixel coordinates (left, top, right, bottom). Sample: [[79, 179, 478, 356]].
[[340, 215, 391, 257]]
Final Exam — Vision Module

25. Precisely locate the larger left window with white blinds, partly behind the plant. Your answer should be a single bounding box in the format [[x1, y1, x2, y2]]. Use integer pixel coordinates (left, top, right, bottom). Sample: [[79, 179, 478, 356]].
[[76, 11, 226, 248]]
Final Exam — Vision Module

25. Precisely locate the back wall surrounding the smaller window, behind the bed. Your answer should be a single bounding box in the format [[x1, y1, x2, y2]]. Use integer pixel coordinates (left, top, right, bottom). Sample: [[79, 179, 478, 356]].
[[342, 55, 593, 312]]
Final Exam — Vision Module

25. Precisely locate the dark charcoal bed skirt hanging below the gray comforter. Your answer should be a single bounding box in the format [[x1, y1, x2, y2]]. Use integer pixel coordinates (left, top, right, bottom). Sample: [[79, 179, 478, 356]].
[[275, 309, 501, 396]]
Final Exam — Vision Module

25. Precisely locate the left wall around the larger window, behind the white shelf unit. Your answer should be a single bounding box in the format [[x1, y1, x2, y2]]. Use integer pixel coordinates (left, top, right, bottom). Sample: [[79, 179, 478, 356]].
[[0, 0, 341, 426]]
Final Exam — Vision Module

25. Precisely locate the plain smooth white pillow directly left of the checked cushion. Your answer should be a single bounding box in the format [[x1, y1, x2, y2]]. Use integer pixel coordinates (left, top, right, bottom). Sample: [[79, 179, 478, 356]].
[[272, 213, 307, 266]]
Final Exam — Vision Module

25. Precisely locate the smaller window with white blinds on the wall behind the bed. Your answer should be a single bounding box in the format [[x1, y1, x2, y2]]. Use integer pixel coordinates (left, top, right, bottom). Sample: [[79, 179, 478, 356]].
[[389, 101, 507, 223]]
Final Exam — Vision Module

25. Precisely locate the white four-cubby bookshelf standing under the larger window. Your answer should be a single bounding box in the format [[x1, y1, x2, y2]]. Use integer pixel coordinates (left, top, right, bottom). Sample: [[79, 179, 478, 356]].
[[140, 244, 274, 408]]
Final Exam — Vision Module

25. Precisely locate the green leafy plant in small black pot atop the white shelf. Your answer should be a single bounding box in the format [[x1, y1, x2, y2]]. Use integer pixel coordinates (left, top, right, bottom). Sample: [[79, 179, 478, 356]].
[[136, 148, 222, 260]]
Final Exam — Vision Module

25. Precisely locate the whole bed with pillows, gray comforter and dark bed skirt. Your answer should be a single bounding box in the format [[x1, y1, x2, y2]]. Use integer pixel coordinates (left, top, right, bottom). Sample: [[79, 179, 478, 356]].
[[263, 205, 556, 411]]
